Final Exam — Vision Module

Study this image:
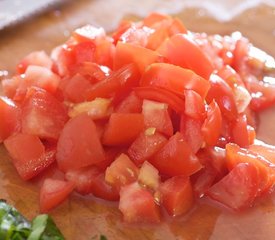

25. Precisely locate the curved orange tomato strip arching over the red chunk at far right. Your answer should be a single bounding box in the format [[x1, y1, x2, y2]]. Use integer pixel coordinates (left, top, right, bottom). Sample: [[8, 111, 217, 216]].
[[226, 143, 275, 195]]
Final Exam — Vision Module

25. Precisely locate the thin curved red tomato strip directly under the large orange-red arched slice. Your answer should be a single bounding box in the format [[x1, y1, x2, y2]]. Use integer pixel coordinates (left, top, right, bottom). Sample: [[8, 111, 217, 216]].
[[134, 87, 184, 113]]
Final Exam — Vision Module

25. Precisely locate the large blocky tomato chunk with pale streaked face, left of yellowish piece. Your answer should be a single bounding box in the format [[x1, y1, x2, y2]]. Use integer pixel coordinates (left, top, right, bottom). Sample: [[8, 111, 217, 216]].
[[22, 87, 68, 140]]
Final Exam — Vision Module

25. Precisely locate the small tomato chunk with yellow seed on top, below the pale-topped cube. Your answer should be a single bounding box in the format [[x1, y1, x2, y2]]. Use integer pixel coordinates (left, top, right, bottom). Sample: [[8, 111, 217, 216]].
[[128, 128, 167, 165]]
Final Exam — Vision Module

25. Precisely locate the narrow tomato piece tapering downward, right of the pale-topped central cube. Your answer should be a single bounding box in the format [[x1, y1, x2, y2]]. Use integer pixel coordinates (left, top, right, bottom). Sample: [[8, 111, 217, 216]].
[[180, 114, 203, 153]]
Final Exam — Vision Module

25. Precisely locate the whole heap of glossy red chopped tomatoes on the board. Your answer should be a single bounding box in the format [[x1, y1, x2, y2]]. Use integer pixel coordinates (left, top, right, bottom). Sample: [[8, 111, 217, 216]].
[[0, 13, 275, 223]]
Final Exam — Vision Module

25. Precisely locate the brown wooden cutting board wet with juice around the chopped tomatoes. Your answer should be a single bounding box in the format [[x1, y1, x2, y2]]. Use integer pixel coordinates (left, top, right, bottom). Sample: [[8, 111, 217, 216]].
[[0, 0, 275, 240]]
